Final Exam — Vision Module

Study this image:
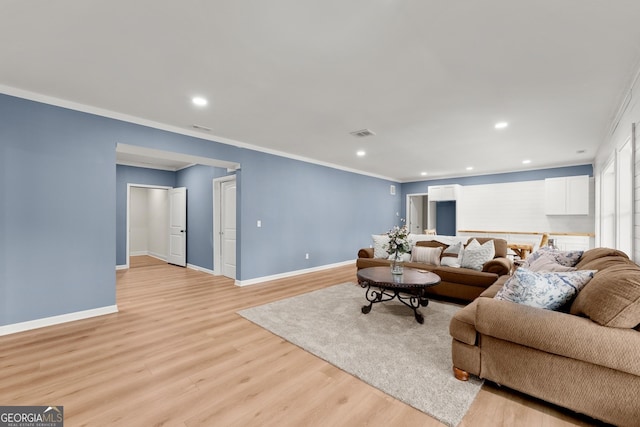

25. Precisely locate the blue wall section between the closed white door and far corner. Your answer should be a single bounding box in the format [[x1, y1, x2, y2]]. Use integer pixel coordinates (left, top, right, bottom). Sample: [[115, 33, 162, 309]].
[[240, 152, 401, 277]]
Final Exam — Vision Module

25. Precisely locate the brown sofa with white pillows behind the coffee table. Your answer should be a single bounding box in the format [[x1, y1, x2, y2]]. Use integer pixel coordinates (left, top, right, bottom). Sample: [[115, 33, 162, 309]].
[[356, 237, 513, 301]]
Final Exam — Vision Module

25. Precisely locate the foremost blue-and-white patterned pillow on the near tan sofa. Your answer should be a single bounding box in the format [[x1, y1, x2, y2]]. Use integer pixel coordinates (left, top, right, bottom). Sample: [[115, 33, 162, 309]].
[[494, 267, 596, 310]]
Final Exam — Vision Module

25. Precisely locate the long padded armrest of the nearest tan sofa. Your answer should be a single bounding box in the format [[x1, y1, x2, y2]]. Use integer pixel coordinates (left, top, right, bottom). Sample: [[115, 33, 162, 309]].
[[476, 298, 640, 376]]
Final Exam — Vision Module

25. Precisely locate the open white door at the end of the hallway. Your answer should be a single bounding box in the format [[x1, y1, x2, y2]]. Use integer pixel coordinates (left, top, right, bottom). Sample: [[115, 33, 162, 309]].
[[167, 187, 187, 267]]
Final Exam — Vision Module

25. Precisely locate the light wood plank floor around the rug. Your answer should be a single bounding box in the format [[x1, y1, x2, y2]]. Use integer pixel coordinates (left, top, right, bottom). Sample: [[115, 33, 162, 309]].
[[0, 260, 604, 427]]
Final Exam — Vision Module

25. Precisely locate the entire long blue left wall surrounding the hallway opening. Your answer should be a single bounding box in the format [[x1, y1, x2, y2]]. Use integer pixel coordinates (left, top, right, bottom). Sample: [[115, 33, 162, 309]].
[[0, 94, 403, 326]]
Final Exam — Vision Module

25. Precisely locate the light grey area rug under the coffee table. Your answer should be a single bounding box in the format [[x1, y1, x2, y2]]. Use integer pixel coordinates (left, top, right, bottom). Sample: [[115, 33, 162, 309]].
[[238, 283, 482, 426]]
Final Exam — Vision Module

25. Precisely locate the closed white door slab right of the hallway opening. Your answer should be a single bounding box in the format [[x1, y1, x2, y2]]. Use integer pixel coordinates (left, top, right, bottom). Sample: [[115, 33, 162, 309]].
[[220, 179, 236, 279]]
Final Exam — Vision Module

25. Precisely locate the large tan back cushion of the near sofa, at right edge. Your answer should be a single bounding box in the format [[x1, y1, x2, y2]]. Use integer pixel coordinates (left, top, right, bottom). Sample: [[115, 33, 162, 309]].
[[570, 262, 640, 328]]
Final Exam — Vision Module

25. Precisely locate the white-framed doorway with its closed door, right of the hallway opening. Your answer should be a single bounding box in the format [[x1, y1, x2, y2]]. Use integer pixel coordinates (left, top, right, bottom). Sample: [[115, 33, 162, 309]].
[[213, 175, 237, 279]]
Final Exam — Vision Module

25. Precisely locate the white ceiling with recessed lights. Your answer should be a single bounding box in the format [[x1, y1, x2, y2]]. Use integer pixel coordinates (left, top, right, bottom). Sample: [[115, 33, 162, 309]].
[[0, 0, 640, 181]]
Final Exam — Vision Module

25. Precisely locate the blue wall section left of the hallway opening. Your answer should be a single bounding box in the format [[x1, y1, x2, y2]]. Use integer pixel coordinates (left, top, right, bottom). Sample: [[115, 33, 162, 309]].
[[0, 95, 116, 325]]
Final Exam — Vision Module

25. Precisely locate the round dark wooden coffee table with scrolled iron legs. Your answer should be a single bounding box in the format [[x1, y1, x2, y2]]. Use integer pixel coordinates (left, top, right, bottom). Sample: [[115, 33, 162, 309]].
[[358, 267, 440, 324]]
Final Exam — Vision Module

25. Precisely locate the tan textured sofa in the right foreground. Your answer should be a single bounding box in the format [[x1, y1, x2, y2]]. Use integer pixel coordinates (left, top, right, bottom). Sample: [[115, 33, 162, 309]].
[[450, 248, 640, 426]]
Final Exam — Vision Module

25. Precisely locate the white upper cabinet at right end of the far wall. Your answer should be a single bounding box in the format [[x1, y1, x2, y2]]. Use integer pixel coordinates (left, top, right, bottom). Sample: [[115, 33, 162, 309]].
[[544, 175, 589, 215]]
